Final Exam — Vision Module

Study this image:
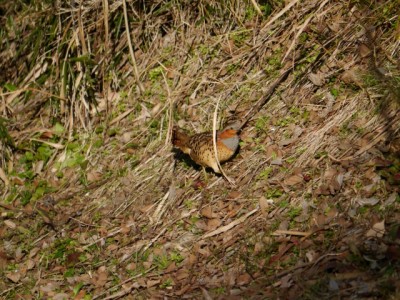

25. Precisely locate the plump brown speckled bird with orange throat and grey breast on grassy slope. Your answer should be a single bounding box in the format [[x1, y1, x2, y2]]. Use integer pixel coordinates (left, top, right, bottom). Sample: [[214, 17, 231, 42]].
[[172, 125, 240, 174]]
